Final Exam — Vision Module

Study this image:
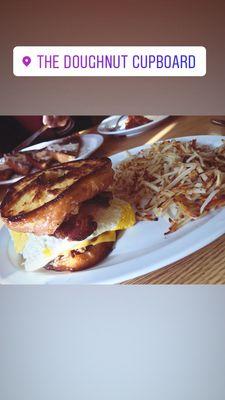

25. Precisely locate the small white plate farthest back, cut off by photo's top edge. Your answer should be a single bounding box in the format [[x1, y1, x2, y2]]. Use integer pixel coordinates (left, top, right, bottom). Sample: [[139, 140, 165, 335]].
[[98, 115, 169, 136]]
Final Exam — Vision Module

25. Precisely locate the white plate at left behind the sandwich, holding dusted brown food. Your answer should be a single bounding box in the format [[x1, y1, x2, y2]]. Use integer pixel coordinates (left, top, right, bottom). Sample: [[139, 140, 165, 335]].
[[0, 133, 104, 185]]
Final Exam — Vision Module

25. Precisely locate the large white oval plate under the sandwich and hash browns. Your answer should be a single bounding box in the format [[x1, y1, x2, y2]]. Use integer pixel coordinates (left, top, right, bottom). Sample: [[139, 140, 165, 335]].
[[0, 136, 225, 284]]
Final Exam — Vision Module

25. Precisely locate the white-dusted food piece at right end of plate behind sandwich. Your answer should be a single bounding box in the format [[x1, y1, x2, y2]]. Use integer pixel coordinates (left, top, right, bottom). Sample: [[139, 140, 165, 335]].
[[47, 134, 80, 163]]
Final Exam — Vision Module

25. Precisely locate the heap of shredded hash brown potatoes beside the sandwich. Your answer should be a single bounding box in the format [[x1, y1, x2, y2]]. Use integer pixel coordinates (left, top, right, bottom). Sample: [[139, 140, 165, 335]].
[[113, 140, 225, 233]]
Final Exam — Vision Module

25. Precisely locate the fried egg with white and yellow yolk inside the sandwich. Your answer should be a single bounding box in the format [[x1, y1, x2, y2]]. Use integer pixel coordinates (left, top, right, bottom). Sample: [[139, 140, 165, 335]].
[[10, 198, 135, 271]]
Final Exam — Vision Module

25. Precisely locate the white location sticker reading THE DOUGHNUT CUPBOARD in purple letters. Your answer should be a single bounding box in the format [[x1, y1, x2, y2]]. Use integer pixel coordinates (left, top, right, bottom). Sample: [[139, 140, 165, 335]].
[[13, 46, 206, 77]]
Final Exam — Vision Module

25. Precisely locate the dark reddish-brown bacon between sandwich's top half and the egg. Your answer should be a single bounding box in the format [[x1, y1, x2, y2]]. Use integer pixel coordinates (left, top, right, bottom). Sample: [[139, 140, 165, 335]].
[[53, 192, 112, 241]]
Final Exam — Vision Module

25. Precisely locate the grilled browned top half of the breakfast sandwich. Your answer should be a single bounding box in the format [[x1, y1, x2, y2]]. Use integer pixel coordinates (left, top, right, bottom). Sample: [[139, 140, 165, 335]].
[[1, 158, 113, 235]]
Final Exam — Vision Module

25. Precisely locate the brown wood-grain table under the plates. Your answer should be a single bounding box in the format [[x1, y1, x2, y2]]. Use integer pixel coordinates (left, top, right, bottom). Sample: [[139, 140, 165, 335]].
[[0, 116, 225, 284]]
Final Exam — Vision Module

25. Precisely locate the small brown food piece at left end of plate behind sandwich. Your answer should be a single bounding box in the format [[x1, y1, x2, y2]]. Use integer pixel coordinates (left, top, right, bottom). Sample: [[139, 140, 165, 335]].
[[4, 152, 32, 175]]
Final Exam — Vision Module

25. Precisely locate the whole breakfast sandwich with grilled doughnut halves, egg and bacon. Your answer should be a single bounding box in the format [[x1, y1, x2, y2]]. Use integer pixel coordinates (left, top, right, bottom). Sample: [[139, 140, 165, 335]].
[[1, 158, 135, 271]]
